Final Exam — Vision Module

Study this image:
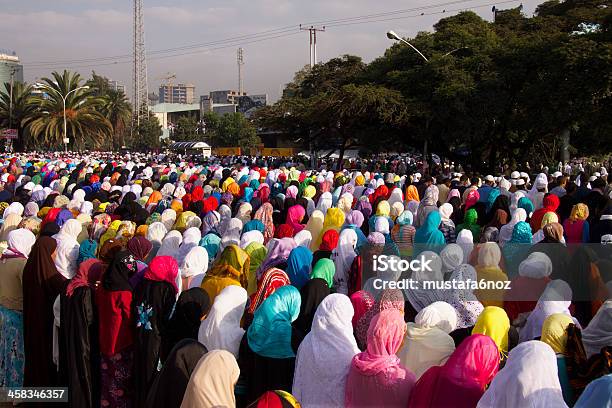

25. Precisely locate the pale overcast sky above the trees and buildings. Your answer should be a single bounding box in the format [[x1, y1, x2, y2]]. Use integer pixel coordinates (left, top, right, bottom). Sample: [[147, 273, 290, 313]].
[[0, 0, 540, 100]]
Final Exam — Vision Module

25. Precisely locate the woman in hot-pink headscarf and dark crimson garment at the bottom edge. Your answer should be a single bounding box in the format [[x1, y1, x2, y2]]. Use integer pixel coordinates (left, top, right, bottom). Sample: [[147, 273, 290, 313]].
[[408, 334, 499, 408]]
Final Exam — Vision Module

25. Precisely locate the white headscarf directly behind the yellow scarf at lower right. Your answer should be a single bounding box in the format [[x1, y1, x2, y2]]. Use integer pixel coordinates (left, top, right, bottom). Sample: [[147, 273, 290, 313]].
[[519, 279, 579, 342]]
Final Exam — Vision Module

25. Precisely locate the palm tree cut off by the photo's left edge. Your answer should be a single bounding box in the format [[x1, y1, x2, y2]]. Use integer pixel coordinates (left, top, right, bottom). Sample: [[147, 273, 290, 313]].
[[0, 82, 35, 151]]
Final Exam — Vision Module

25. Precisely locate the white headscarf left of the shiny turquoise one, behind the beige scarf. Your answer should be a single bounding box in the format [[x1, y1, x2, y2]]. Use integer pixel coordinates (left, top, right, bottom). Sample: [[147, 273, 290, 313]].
[[198, 285, 248, 357]]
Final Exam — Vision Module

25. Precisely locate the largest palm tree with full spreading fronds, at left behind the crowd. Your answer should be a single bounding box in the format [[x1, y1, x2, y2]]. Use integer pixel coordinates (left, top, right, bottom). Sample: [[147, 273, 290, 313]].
[[29, 70, 112, 149]]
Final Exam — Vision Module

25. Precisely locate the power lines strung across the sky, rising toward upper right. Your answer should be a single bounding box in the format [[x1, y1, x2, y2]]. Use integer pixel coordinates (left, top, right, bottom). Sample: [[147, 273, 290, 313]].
[[24, 0, 520, 70]]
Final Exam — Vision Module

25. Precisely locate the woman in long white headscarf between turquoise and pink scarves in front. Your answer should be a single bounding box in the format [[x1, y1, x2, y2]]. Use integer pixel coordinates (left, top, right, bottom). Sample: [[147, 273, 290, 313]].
[[292, 294, 359, 407]]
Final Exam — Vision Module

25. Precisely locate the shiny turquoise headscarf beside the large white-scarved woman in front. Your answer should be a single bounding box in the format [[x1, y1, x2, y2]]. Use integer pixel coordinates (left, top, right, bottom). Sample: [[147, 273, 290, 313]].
[[247, 285, 302, 358]]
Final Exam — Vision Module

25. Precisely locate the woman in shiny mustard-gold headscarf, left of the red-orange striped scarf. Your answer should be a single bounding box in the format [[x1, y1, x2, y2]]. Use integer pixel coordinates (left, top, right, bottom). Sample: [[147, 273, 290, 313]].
[[201, 245, 250, 304]]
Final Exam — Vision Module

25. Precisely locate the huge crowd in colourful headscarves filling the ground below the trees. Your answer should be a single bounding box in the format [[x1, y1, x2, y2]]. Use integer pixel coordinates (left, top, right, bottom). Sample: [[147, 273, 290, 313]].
[[0, 153, 612, 408]]
